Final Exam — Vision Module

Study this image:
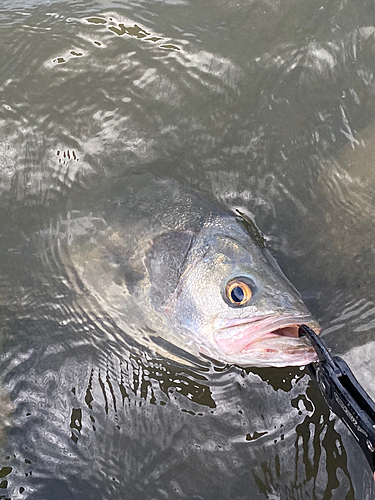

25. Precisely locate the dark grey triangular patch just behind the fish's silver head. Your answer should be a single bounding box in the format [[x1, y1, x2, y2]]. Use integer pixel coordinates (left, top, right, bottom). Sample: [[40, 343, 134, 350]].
[[146, 231, 194, 310]]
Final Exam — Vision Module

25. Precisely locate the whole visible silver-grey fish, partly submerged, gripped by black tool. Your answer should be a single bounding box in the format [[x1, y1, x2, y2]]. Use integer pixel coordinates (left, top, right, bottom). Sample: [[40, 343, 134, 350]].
[[68, 173, 316, 366]]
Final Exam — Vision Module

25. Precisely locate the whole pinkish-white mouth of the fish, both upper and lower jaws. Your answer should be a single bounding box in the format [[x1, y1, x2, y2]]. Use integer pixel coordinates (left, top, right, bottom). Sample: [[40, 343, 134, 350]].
[[213, 315, 320, 367]]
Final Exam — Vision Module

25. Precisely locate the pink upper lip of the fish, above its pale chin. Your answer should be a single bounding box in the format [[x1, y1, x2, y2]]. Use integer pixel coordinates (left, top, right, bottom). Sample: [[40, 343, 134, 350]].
[[214, 314, 321, 356]]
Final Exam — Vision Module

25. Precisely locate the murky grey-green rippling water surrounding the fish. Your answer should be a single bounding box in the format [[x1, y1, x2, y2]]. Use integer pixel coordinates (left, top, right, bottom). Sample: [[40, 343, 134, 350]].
[[0, 0, 375, 500]]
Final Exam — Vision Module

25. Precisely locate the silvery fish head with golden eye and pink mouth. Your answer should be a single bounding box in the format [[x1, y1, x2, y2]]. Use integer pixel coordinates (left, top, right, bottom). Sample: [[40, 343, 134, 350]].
[[164, 223, 320, 367]]
